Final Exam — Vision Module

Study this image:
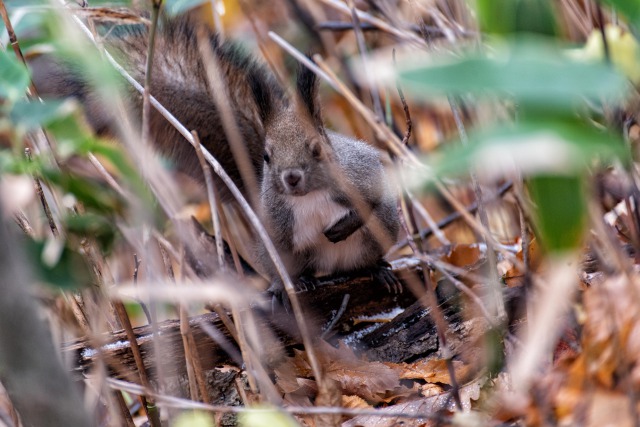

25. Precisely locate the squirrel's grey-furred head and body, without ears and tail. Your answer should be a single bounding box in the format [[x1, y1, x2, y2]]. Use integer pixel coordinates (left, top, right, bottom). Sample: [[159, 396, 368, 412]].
[[260, 107, 399, 286]]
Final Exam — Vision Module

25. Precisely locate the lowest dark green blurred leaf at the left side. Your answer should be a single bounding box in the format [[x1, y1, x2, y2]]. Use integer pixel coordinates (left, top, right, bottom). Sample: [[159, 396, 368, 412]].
[[25, 240, 93, 290]]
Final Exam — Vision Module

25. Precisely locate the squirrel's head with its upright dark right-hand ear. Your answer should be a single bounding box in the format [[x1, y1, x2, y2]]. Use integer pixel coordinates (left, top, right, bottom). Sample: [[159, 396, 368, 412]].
[[262, 66, 334, 196]]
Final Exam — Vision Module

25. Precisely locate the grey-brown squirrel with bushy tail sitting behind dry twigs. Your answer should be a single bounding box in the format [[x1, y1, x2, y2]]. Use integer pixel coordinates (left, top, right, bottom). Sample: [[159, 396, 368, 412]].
[[30, 18, 399, 301]]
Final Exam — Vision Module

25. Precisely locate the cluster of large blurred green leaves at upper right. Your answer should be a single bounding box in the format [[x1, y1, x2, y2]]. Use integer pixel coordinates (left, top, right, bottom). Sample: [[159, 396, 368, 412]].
[[400, 0, 638, 251]]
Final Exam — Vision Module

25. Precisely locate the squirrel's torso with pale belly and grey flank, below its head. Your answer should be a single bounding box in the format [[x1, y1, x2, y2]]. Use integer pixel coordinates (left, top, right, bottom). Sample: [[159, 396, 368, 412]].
[[261, 127, 397, 276]]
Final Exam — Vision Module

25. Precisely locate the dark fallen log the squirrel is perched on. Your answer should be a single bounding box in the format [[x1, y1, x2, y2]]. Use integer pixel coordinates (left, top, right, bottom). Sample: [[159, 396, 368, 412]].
[[62, 259, 419, 383]]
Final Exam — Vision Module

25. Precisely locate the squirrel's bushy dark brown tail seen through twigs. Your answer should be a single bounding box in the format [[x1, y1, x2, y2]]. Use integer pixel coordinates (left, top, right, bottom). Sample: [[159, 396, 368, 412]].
[[30, 19, 286, 201]]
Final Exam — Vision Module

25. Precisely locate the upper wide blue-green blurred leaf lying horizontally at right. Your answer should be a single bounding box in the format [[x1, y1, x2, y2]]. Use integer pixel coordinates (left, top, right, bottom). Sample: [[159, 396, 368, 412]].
[[399, 43, 628, 109]]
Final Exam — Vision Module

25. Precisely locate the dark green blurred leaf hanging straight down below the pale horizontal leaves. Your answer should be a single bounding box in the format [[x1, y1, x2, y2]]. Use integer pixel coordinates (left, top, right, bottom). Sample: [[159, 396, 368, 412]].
[[527, 175, 587, 252]]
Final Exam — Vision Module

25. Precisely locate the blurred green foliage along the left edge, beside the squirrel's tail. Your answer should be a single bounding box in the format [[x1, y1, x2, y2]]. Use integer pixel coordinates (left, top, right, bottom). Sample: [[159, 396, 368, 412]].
[[0, 10, 153, 289]]
